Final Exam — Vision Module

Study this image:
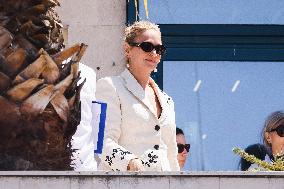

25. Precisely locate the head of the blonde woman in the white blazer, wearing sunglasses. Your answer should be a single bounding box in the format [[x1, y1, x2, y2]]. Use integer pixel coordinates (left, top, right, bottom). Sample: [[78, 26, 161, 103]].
[[124, 21, 165, 73]]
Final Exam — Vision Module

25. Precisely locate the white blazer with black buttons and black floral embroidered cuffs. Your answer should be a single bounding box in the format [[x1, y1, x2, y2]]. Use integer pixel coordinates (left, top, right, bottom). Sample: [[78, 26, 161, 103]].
[[96, 69, 179, 171]]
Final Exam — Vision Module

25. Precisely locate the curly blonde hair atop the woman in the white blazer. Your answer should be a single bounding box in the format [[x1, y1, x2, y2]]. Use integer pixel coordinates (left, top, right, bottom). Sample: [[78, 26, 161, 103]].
[[124, 20, 161, 43]]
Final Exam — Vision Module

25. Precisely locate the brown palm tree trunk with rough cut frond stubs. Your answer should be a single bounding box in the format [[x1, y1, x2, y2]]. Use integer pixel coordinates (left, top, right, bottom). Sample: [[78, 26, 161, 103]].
[[0, 0, 86, 170]]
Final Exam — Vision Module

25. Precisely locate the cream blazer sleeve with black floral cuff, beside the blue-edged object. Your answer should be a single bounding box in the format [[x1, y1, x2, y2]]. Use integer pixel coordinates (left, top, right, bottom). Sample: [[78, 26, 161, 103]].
[[96, 78, 137, 171]]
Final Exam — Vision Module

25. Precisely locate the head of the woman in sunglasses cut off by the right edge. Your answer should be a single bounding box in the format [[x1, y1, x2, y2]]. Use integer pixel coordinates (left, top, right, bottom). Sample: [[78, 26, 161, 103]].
[[262, 111, 284, 155]]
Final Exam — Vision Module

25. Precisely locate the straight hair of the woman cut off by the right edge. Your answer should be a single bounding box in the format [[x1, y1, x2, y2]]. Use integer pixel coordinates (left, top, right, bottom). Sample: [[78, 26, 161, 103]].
[[262, 111, 284, 147]]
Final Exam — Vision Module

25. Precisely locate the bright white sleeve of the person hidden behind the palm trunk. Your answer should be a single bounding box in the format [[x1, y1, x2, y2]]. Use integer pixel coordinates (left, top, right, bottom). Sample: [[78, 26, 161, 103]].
[[72, 63, 97, 171]]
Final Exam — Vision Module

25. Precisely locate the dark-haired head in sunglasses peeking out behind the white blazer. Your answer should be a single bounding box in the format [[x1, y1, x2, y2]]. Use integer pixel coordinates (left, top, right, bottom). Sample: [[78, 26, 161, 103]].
[[176, 127, 190, 168]]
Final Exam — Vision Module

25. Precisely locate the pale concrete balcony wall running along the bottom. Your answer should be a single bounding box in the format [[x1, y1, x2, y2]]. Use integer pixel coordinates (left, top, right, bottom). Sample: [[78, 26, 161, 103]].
[[0, 171, 284, 189]]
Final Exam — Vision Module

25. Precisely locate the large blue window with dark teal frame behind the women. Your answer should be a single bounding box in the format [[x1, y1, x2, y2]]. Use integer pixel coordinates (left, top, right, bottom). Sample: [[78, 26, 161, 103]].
[[129, 0, 284, 170]]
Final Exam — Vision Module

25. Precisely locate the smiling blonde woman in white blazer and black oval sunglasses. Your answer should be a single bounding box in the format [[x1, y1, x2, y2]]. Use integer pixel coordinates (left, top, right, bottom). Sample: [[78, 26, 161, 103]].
[[96, 21, 179, 171]]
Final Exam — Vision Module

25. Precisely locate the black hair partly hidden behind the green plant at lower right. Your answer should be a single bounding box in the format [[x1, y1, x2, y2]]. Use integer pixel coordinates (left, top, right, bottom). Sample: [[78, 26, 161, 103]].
[[239, 143, 270, 171]]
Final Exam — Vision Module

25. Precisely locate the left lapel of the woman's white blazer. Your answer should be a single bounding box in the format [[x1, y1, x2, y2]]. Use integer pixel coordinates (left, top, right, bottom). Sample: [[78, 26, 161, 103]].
[[120, 69, 156, 117]]
